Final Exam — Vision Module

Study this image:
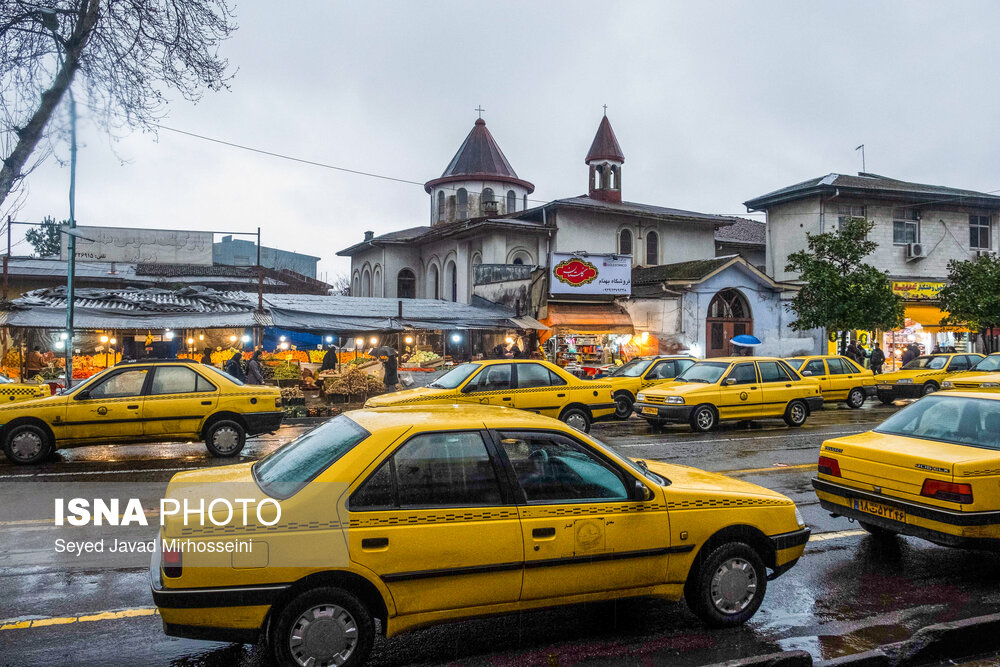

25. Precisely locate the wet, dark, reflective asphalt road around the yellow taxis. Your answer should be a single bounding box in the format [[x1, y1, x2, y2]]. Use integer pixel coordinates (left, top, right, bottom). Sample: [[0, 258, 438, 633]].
[[0, 404, 1000, 667]]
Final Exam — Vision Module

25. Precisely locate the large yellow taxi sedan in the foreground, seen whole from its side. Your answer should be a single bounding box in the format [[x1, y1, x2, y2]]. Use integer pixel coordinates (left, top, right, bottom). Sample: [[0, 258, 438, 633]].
[[150, 405, 809, 666]]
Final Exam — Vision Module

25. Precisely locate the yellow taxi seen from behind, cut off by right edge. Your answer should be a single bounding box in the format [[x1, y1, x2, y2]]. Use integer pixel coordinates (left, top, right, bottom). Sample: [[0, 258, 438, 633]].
[[812, 391, 1000, 549]]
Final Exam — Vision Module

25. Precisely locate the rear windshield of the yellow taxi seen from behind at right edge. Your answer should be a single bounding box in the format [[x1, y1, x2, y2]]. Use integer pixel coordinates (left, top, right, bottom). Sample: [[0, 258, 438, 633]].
[[875, 395, 1000, 450]]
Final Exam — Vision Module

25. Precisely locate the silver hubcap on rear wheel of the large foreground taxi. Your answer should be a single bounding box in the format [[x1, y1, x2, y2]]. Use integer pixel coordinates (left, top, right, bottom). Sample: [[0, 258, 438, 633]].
[[288, 604, 358, 667]]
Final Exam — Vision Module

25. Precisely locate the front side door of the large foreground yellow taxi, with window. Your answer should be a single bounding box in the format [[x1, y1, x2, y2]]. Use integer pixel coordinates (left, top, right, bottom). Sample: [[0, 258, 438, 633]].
[[498, 431, 670, 600]]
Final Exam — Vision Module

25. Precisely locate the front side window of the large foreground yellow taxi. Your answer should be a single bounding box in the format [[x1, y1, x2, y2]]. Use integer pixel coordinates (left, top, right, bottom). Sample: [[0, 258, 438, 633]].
[[501, 433, 628, 503]]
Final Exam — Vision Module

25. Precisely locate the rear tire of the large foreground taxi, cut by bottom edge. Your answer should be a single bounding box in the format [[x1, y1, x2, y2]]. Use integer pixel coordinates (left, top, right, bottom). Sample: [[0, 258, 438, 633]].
[[268, 587, 375, 667]]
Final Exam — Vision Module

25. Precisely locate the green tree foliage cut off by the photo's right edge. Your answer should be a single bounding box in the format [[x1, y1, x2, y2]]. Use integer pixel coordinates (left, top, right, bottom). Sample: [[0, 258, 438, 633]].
[[938, 255, 1000, 352]]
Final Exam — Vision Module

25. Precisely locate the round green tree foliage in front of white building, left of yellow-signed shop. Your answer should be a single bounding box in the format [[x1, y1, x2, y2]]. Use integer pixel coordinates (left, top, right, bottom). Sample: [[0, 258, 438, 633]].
[[785, 218, 904, 343]]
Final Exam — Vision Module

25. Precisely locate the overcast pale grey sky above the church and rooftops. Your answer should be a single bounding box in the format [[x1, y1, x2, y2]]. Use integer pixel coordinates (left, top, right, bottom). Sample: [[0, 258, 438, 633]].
[[7, 0, 1000, 274]]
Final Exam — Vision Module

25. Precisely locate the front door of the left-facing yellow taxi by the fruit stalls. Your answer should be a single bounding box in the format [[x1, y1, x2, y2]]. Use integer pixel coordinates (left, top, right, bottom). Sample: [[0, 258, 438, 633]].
[[61, 367, 150, 440]]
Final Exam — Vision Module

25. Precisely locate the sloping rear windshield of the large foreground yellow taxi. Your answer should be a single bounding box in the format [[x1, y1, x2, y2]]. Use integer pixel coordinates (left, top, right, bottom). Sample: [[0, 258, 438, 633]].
[[253, 415, 371, 499]]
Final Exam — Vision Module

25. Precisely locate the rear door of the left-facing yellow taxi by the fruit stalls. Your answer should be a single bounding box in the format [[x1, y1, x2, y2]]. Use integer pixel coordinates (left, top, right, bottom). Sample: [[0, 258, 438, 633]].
[[142, 366, 219, 437]]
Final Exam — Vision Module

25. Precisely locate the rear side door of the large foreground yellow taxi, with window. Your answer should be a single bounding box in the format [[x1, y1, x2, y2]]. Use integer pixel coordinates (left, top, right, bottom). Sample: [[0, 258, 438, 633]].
[[348, 431, 524, 614]]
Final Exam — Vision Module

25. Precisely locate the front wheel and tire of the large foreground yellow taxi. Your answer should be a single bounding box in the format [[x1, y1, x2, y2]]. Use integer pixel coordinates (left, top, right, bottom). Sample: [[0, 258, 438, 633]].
[[684, 542, 767, 628]]
